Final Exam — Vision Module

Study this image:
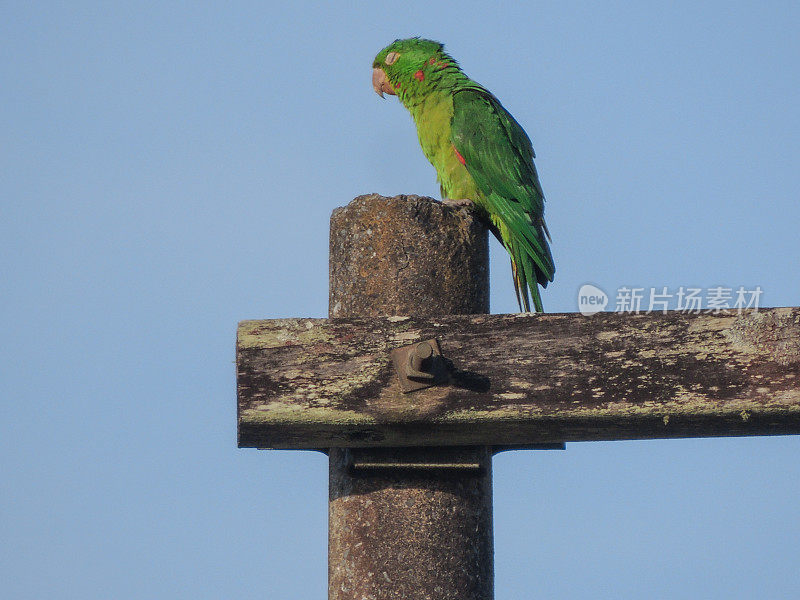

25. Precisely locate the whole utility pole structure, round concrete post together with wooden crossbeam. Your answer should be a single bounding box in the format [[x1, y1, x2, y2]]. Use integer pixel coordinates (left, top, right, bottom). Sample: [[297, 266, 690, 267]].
[[237, 195, 800, 600]]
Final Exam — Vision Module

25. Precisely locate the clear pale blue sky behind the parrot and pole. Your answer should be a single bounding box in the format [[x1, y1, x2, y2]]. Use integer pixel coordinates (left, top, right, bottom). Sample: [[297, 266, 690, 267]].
[[0, 1, 800, 600]]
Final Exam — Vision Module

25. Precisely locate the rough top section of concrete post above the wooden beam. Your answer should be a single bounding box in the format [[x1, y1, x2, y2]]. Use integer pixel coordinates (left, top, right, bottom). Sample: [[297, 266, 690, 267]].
[[328, 194, 489, 317]]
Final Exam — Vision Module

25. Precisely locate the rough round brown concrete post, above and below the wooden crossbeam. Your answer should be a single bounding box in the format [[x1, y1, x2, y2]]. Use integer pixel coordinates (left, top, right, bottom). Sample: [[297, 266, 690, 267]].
[[328, 195, 494, 600]]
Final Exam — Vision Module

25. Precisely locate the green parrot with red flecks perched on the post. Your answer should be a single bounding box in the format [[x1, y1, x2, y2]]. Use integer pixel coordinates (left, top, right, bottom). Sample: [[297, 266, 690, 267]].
[[372, 38, 555, 312]]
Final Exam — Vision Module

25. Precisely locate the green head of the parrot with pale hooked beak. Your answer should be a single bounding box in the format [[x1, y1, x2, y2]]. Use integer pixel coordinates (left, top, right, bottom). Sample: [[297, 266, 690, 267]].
[[372, 38, 458, 100]]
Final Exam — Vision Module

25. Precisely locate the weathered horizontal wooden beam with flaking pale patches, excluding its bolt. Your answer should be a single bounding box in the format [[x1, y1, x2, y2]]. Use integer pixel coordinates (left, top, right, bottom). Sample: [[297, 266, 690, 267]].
[[237, 308, 800, 448]]
